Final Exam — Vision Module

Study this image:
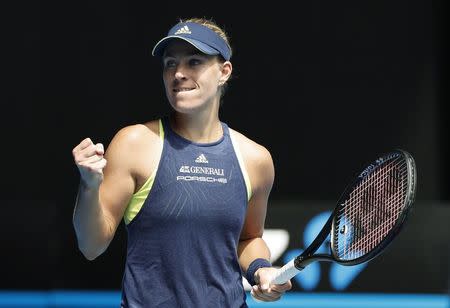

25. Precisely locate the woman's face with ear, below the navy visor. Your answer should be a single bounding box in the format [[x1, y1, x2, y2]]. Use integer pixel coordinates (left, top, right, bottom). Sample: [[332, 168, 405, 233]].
[[163, 40, 231, 113]]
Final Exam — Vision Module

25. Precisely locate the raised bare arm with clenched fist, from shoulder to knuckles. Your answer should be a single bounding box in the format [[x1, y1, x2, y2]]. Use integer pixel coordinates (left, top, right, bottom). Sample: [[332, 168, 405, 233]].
[[72, 125, 158, 260]]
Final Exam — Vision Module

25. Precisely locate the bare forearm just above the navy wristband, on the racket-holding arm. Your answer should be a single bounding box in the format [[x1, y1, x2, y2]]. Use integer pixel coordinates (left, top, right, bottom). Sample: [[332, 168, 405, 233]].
[[238, 237, 270, 272]]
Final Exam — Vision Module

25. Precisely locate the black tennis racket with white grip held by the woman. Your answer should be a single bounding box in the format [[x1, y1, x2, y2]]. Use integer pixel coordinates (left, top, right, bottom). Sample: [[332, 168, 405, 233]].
[[271, 149, 416, 284]]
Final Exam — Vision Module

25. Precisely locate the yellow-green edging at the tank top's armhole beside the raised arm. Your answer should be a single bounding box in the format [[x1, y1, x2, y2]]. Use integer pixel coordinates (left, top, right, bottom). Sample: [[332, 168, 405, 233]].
[[123, 119, 164, 225]]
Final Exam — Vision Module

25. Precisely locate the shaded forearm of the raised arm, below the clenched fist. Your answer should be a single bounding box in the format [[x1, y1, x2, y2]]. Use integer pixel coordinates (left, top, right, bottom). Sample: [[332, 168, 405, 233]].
[[73, 183, 114, 260]]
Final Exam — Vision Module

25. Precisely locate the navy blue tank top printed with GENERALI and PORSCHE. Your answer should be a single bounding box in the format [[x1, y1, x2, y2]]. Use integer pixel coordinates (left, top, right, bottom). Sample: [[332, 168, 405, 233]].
[[122, 118, 247, 308]]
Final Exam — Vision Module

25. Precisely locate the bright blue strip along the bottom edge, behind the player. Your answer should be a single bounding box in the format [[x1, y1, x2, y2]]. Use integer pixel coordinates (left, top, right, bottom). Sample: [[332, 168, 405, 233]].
[[0, 290, 450, 308]]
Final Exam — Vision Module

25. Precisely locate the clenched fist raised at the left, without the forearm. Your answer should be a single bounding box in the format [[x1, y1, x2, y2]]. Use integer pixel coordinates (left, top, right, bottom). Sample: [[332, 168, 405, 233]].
[[72, 138, 106, 188]]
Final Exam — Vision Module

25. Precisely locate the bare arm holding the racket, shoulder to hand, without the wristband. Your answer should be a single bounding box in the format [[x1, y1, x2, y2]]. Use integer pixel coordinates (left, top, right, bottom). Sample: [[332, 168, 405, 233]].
[[234, 132, 292, 301]]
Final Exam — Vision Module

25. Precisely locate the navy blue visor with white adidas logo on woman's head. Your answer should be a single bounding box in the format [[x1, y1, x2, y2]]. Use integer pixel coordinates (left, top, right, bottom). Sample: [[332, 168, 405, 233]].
[[152, 22, 231, 61]]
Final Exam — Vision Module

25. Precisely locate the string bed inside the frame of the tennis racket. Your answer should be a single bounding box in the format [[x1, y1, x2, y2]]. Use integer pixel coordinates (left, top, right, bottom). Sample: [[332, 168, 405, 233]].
[[334, 159, 408, 260]]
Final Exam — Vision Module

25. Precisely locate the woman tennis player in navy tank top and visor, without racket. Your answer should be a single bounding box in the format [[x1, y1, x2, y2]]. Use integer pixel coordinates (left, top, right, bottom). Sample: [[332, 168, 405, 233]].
[[73, 18, 292, 308]]
